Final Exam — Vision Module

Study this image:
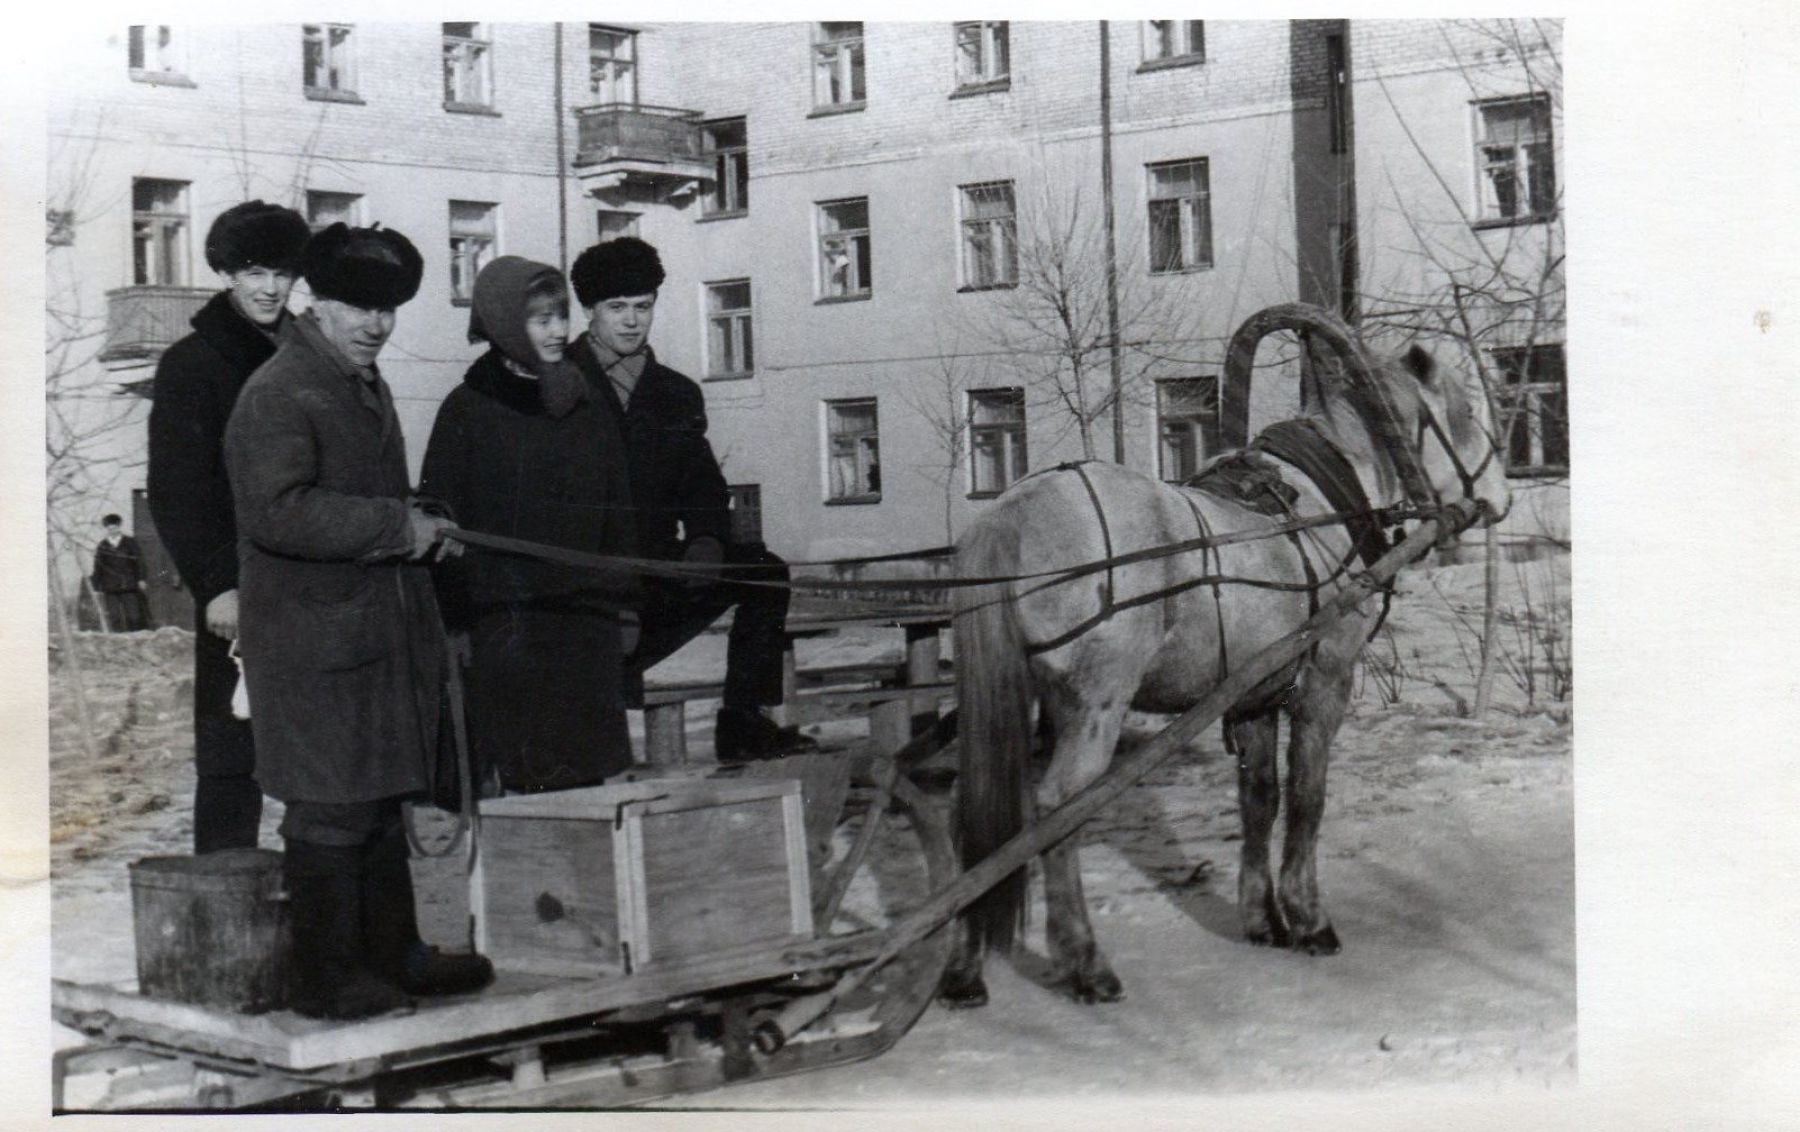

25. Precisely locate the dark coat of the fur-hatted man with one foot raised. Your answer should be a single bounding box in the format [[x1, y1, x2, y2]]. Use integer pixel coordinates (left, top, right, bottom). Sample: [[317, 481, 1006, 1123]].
[[569, 335, 731, 560]]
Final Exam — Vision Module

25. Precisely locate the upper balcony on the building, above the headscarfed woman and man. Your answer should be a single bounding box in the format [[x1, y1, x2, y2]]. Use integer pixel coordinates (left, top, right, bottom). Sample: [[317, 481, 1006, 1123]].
[[574, 103, 713, 196]]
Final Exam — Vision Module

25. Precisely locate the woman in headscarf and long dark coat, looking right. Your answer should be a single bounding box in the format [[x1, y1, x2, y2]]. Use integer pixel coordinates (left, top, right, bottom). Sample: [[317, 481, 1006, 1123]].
[[419, 256, 637, 792]]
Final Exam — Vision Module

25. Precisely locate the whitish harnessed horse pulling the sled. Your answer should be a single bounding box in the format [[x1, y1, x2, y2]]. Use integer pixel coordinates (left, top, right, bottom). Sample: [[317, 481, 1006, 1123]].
[[943, 308, 1510, 1006]]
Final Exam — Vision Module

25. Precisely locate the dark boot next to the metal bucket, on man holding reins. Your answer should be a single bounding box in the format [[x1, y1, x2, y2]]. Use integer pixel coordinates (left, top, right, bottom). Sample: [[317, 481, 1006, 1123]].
[[283, 839, 412, 1019]]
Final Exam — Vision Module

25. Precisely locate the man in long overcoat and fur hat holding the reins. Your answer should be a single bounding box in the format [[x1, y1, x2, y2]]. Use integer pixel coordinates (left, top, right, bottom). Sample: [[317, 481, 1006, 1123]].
[[225, 223, 493, 1019]]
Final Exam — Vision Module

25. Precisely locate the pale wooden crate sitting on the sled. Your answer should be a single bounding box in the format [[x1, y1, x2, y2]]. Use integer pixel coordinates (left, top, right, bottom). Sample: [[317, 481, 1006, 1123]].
[[470, 777, 812, 975]]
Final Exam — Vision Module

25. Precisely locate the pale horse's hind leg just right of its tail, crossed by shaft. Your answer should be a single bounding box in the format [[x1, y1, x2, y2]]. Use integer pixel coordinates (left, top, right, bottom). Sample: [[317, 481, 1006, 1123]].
[[1039, 700, 1125, 1002]]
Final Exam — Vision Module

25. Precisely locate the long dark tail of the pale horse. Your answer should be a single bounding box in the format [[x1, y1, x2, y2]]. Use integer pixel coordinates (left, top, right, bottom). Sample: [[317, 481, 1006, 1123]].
[[954, 504, 1037, 948]]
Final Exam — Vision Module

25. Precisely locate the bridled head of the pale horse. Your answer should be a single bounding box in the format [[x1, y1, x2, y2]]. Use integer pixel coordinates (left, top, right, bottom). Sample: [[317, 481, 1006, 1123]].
[[1381, 344, 1512, 526]]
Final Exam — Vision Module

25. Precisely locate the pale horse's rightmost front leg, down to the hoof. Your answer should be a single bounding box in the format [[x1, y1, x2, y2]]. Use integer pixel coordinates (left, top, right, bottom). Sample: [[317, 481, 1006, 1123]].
[[1280, 664, 1350, 956]]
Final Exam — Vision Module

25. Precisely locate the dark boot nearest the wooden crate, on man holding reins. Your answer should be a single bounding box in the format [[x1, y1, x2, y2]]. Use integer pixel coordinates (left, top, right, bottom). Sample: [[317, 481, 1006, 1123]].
[[362, 821, 493, 995]]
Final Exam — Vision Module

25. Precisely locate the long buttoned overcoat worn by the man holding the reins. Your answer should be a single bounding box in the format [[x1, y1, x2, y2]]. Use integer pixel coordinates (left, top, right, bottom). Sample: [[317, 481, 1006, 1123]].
[[225, 315, 445, 803]]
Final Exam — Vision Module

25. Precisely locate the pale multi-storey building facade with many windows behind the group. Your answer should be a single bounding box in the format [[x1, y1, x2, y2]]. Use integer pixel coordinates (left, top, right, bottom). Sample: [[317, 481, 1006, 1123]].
[[49, 20, 1568, 579]]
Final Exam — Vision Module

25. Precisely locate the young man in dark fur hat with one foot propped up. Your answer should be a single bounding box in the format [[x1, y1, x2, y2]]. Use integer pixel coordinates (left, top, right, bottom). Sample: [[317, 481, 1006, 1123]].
[[569, 236, 817, 761]]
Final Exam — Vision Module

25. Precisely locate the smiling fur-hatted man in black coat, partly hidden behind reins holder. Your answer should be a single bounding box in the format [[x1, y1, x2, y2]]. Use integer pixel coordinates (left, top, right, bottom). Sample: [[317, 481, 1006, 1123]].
[[148, 200, 311, 853]]
